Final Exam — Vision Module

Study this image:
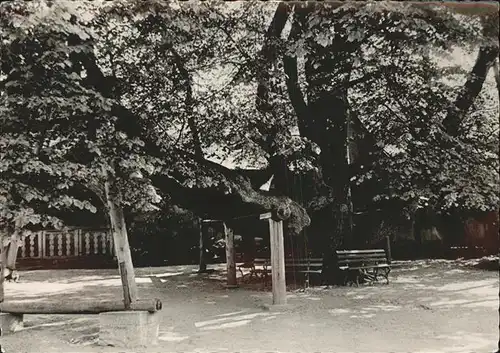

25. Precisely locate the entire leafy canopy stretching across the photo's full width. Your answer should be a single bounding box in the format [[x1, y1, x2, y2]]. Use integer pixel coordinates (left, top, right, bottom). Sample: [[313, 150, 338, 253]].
[[0, 0, 499, 239]]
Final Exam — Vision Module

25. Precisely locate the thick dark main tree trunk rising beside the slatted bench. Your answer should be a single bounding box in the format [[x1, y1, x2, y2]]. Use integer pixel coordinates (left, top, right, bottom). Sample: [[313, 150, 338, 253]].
[[299, 4, 359, 283]]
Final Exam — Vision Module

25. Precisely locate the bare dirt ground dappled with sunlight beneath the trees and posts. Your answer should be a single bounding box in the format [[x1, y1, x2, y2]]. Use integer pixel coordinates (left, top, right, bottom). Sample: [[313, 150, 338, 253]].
[[1, 260, 499, 353]]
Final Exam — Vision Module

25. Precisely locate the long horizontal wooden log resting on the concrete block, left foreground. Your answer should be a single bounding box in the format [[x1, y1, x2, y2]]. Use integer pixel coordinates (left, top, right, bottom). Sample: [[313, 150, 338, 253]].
[[0, 299, 163, 315]]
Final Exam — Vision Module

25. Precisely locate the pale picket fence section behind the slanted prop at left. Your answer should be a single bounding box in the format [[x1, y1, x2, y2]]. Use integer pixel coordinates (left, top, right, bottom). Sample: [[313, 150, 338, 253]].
[[18, 229, 115, 259]]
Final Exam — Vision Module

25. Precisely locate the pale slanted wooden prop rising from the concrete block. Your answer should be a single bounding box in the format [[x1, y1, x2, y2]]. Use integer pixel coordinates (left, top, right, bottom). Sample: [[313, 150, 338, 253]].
[[105, 168, 137, 307]]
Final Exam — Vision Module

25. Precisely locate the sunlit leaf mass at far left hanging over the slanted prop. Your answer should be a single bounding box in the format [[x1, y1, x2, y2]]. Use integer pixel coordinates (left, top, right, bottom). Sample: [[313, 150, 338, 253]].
[[0, 2, 162, 231]]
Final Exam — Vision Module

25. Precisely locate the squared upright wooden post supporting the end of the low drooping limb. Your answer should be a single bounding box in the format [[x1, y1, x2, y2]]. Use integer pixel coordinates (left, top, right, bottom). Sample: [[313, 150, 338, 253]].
[[260, 213, 287, 305]]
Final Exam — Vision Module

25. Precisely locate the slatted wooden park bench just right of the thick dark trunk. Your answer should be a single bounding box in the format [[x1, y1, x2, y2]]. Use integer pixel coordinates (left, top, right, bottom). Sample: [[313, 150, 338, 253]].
[[336, 249, 391, 286]]
